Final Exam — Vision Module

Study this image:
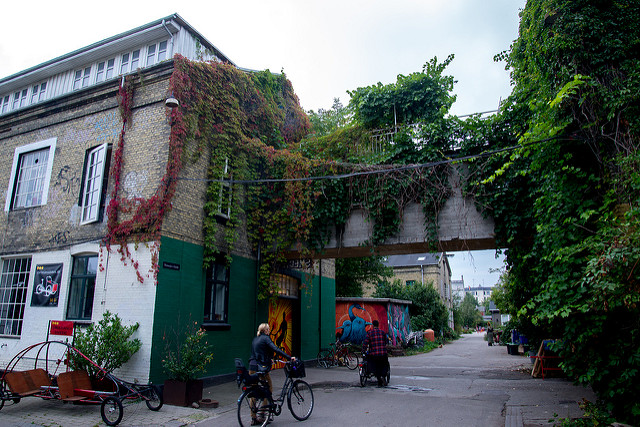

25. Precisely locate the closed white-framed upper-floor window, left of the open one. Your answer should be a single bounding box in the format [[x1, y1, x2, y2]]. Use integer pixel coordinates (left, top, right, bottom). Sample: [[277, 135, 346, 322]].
[[4, 138, 56, 211]]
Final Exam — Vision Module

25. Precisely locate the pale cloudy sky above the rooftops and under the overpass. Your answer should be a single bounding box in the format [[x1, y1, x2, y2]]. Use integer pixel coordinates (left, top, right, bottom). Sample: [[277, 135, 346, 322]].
[[0, 0, 526, 286]]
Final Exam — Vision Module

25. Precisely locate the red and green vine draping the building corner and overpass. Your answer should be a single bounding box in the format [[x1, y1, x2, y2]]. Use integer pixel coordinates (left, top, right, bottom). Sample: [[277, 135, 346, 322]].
[[165, 56, 449, 298]]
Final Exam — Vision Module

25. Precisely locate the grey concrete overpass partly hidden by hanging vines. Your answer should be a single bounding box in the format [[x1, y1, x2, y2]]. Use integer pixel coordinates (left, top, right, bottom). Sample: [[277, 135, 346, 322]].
[[298, 166, 496, 259]]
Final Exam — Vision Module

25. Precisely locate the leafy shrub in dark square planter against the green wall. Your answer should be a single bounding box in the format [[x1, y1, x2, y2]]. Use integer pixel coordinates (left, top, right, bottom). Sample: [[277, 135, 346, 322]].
[[162, 323, 213, 406]]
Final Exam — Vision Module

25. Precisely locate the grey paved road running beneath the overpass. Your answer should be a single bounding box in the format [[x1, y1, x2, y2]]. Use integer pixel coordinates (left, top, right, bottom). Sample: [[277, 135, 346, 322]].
[[0, 334, 595, 427]]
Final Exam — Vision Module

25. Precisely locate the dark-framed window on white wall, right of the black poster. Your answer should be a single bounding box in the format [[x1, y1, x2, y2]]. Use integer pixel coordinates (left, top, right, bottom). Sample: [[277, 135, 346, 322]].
[[67, 255, 98, 320]]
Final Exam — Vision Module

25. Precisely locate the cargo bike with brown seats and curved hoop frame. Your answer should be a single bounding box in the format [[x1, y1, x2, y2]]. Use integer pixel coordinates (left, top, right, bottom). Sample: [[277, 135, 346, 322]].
[[0, 341, 163, 426]]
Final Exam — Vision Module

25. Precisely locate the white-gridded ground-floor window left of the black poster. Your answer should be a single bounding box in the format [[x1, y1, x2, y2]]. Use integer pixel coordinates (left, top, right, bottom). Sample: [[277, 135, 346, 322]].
[[0, 257, 31, 337]]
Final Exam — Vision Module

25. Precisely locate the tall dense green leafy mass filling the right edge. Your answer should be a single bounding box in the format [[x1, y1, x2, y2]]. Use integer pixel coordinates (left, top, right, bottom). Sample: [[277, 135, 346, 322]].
[[479, 0, 640, 424]]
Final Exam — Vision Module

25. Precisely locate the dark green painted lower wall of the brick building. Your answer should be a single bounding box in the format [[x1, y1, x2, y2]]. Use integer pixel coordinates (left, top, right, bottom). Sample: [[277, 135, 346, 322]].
[[150, 237, 335, 383]]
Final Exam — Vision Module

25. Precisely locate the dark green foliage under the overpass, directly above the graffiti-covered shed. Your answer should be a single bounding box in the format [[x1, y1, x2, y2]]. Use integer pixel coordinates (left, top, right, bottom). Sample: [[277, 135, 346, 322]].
[[336, 256, 393, 297]]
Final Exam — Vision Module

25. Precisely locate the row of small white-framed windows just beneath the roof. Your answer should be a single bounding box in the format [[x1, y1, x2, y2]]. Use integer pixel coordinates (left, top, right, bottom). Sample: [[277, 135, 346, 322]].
[[0, 40, 168, 114]]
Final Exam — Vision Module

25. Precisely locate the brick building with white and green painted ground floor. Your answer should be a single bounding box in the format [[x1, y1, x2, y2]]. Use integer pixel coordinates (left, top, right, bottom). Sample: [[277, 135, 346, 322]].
[[0, 14, 335, 382]]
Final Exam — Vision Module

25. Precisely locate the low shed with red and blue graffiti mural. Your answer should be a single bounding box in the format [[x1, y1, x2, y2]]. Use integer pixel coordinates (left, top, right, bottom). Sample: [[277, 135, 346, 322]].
[[336, 297, 411, 345]]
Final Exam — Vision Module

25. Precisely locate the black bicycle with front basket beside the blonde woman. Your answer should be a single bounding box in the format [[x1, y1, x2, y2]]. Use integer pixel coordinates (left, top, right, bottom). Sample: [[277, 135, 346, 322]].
[[235, 359, 313, 427]]
